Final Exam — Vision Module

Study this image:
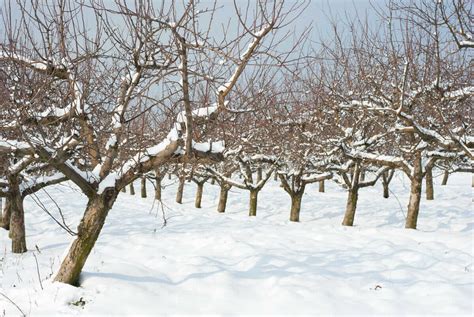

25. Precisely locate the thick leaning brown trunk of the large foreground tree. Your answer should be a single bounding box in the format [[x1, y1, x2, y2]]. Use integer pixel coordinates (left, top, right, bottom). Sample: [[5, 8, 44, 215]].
[[54, 189, 117, 286]]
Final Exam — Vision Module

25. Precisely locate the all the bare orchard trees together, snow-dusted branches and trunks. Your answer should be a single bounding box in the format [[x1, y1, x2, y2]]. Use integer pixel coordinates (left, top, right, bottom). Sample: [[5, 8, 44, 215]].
[[0, 0, 474, 285]]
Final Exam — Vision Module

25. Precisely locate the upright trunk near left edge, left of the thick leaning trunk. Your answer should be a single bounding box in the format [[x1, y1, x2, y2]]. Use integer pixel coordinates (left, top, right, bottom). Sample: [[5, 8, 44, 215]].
[[8, 176, 26, 253]]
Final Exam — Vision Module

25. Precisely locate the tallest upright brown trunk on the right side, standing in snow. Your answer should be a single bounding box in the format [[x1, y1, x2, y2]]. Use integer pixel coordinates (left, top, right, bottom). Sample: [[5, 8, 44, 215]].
[[405, 154, 423, 229]]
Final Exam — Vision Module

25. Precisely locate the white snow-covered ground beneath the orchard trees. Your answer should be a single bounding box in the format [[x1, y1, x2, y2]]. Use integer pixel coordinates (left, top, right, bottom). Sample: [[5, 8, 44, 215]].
[[0, 174, 474, 316]]
